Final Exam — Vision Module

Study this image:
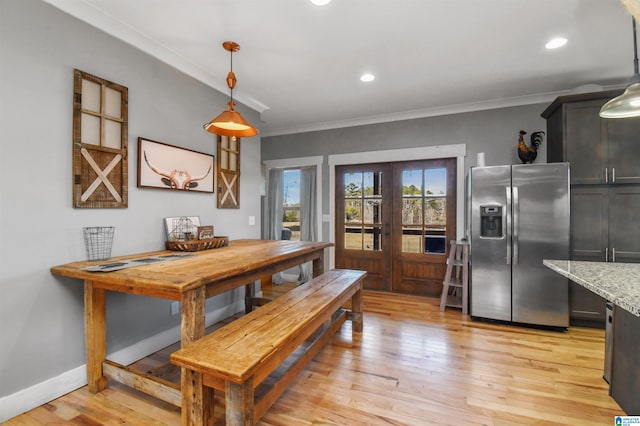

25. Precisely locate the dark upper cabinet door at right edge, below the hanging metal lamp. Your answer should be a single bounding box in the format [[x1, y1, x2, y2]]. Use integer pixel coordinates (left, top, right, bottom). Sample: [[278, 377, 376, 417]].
[[604, 118, 640, 183]]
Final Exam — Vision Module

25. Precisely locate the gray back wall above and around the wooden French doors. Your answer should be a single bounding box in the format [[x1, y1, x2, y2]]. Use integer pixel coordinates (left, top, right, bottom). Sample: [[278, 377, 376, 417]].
[[262, 104, 548, 240]]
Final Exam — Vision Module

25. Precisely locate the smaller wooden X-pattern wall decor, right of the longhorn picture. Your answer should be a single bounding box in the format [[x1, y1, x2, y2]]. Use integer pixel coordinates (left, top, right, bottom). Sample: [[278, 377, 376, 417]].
[[217, 136, 240, 209]]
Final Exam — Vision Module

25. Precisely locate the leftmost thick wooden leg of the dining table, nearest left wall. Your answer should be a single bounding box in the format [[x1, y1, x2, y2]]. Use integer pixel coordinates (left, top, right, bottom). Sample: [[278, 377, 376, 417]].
[[84, 280, 107, 393]]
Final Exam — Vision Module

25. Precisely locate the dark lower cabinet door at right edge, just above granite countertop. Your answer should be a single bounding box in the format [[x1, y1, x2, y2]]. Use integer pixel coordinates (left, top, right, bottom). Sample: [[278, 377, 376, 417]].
[[609, 185, 640, 262]]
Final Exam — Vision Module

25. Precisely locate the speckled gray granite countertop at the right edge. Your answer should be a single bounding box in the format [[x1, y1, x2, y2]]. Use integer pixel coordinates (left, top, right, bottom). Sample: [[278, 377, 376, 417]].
[[542, 259, 640, 317]]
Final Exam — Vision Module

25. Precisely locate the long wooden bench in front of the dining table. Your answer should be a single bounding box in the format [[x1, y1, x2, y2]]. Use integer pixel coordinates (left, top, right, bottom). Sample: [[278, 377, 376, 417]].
[[171, 269, 366, 425]]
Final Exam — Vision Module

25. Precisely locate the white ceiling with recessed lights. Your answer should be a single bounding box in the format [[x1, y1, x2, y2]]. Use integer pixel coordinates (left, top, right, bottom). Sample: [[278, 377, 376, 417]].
[[45, 0, 633, 136]]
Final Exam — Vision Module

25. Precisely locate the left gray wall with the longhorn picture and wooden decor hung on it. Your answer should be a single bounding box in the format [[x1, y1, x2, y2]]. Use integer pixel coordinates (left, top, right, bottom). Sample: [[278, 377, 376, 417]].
[[0, 0, 260, 412]]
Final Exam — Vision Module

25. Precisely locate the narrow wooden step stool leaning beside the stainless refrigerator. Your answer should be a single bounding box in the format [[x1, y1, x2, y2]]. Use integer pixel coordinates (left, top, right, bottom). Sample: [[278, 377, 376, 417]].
[[440, 240, 469, 314]]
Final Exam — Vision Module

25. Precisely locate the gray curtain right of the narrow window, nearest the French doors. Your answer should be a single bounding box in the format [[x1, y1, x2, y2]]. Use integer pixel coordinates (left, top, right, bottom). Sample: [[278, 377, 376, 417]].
[[298, 167, 318, 284]]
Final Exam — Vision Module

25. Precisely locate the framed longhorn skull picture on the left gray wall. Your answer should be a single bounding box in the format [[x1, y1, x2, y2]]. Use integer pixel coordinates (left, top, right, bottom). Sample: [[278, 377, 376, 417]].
[[138, 138, 214, 193]]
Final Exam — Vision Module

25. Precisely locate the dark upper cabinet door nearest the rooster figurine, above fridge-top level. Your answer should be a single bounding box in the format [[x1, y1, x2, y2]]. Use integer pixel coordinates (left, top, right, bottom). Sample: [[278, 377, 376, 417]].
[[564, 99, 607, 184]]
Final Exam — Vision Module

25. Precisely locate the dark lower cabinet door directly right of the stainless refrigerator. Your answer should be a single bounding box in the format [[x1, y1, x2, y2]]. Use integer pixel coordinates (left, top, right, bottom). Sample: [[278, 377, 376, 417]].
[[570, 185, 609, 262]]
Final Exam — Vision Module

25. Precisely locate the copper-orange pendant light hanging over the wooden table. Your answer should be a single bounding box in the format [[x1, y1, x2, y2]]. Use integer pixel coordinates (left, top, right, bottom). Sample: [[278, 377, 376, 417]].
[[203, 41, 258, 140]]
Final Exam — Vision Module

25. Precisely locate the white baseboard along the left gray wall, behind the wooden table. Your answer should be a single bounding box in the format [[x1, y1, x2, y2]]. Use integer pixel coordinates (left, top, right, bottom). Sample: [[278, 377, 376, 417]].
[[0, 300, 244, 423]]
